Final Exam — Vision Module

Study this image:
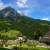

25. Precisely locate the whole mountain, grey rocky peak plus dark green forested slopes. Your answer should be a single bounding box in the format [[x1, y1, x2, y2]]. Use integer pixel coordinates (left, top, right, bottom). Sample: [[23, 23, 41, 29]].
[[0, 7, 50, 39]]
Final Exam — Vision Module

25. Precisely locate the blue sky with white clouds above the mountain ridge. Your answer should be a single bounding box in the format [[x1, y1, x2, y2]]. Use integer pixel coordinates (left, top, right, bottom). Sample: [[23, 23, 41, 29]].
[[0, 0, 50, 21]]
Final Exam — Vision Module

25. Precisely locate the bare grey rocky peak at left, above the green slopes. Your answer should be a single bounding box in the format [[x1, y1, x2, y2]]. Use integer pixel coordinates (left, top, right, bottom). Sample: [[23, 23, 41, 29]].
[[0, 7, 20, 19]]
